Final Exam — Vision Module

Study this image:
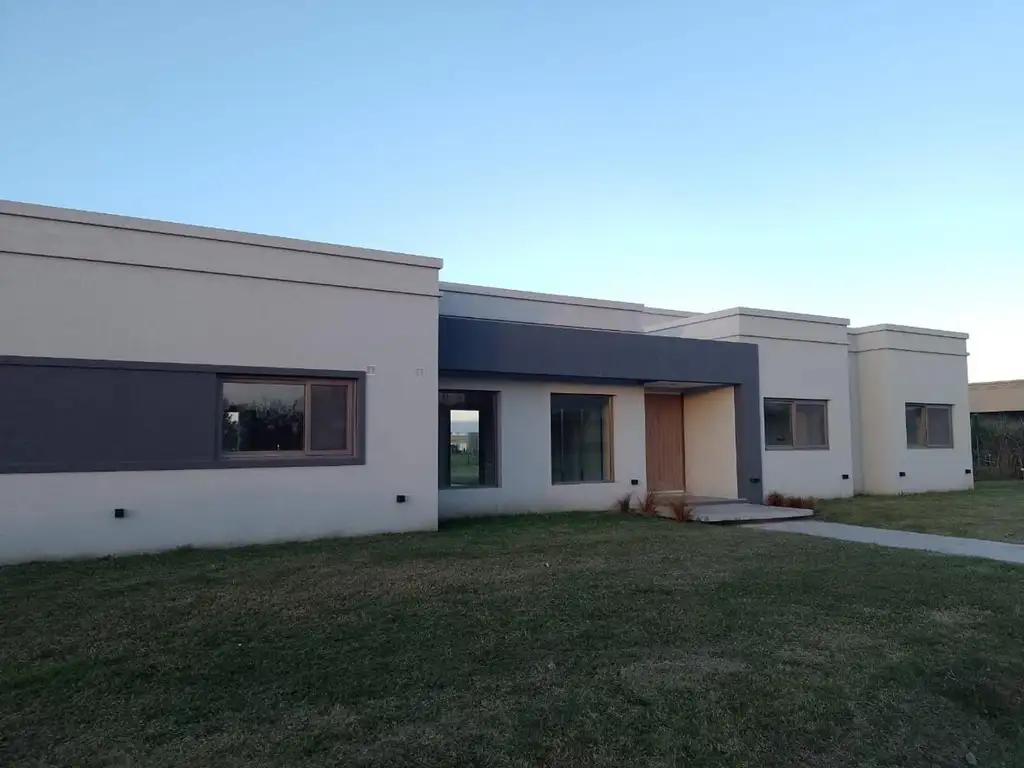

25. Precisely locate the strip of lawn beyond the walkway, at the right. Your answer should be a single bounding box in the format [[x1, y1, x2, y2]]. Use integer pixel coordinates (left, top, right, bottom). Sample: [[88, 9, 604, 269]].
[[819, 480, 1024, 544]]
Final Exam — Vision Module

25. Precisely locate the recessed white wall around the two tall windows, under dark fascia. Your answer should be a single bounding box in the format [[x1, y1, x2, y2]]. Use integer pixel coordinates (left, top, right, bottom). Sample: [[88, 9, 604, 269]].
[[434, 379, 646, 518]]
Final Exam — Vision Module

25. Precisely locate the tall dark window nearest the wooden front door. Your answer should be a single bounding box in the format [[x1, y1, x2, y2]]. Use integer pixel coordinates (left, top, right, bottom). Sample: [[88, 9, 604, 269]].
[[551, 394, 612, 483]]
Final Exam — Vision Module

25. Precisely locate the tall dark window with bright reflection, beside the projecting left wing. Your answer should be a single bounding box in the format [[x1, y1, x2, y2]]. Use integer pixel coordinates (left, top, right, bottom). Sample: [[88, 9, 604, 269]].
[[437, 389, 498, 488]]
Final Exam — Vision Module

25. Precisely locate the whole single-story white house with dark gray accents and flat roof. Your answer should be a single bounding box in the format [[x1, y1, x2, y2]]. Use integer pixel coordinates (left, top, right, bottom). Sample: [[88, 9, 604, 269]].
[[0, 203, 973, 560]]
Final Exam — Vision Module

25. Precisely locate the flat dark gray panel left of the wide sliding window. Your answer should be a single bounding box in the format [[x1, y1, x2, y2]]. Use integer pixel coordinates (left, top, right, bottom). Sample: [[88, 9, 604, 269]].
[[0, 365, 219, 472]]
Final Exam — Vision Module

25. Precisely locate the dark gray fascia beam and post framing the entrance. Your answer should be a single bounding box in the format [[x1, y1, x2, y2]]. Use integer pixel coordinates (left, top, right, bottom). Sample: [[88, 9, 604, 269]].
[[438, 315, 763, 503]]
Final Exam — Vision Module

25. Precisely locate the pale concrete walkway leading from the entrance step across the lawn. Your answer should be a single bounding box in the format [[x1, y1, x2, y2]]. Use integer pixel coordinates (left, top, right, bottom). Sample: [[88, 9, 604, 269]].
[[751, 520, 1024, 564]]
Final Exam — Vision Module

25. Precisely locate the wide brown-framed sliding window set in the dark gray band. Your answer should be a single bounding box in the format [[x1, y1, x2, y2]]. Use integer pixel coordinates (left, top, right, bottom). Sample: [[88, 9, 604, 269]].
[[220, 379, 355, 459]]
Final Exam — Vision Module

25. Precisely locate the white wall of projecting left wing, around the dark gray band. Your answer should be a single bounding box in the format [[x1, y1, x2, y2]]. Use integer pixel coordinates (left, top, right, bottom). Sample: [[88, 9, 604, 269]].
[[0, 206, 439, 561]]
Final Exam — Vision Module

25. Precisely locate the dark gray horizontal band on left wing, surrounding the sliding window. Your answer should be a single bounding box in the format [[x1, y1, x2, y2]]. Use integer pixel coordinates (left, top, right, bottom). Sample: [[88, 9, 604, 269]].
[[0, 357, 367, 473]]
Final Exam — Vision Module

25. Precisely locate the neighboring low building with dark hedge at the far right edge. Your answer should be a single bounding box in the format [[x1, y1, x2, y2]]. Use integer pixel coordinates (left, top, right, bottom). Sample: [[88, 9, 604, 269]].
[[970, 379, 1024, 479]]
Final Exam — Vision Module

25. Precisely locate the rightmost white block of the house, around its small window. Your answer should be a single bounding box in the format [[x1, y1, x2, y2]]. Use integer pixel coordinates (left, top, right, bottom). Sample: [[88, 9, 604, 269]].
[[850, 326, 974, 494]]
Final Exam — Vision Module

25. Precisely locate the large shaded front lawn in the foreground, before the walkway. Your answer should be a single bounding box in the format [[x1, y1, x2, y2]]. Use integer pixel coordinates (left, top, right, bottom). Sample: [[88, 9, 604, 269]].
[[0, 514, 1024, 768]]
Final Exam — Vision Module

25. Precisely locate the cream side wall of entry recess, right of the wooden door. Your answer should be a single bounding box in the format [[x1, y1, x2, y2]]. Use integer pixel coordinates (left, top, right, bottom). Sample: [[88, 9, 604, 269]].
[[683, 387, 738, 499]]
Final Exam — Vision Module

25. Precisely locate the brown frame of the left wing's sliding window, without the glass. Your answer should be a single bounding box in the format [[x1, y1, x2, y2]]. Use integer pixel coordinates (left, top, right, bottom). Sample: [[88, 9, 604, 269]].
[[217, 376, 362, 463]]
